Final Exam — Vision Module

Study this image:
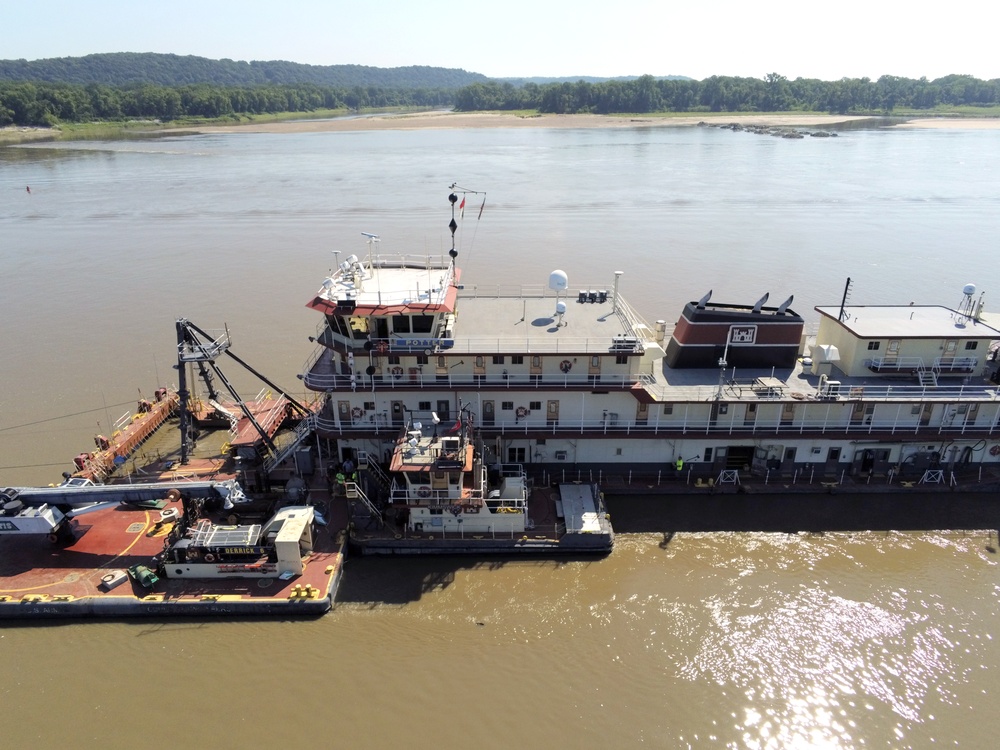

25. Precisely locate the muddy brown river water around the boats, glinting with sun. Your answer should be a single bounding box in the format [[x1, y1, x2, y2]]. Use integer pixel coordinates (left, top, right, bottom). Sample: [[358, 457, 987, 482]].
[[0, 122, 1000, 748]]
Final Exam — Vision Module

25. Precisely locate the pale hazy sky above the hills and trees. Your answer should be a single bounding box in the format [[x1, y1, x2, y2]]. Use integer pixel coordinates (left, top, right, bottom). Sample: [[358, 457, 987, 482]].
[[0, 0, 1000, 80]]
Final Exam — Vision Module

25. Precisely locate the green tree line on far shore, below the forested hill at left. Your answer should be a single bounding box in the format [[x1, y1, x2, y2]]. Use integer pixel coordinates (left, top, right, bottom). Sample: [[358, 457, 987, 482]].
[[0, 81, 454, 127]]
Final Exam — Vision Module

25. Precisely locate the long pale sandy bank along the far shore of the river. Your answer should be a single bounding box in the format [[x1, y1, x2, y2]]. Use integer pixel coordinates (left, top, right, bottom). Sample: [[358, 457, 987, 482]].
[[182, 112, 1000, 133]]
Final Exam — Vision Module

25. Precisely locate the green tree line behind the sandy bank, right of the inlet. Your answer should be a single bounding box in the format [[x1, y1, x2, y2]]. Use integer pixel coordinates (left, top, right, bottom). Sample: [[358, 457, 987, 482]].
[[455, 73, 1000, 114]]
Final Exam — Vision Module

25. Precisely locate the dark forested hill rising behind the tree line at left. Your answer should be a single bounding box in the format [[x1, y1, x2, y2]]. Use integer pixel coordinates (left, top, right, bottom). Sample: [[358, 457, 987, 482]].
[[0, 52, 489, 89]]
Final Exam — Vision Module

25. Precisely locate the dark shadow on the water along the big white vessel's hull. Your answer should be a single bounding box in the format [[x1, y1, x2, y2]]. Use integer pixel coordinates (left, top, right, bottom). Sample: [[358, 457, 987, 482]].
[[607, 490, 1000, 544]]
